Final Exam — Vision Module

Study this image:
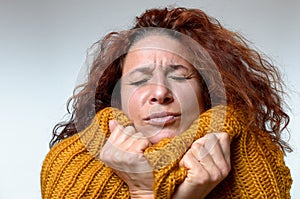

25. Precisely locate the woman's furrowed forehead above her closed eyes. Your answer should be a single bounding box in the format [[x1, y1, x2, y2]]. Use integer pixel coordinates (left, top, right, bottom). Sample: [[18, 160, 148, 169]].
[[123, 35, 192, 73]]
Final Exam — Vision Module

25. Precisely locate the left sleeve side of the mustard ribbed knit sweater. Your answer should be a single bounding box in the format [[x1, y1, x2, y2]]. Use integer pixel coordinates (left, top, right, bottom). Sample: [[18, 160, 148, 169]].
[[40, 109, 130, 199]]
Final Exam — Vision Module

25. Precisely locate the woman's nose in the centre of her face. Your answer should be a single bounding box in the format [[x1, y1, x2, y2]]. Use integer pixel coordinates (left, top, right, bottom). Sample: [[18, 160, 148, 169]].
[[149, 84, 174, 105]]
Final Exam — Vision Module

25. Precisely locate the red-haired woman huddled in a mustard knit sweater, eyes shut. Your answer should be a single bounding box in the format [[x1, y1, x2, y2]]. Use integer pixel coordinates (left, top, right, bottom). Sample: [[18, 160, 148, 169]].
[[41, 8, 291, 198]]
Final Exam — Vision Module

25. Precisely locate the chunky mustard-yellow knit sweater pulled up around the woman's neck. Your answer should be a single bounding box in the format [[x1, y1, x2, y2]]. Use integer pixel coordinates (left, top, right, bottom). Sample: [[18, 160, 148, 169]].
[[41, 106, 292, 199]]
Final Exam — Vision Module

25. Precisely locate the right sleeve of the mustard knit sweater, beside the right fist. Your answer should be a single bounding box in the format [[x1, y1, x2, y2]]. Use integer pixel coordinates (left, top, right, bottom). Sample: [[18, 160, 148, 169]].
[[207, 126, 292, 199]]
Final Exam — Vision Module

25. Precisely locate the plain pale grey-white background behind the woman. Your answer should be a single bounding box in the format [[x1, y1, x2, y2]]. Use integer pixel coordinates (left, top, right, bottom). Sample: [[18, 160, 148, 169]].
[[0, 0, 300, 199]]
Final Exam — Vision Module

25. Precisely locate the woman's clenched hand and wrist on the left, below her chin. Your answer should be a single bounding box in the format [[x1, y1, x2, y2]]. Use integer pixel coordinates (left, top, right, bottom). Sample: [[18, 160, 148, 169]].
[[100, 120, 154, 198]]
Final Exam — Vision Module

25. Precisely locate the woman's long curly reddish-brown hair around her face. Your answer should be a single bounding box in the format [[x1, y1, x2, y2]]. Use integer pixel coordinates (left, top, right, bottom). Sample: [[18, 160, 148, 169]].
[[50, 8, 292, 152]]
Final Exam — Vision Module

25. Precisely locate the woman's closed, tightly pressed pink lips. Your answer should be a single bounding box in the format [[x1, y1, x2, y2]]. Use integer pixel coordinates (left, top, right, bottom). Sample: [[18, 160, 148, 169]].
[[143, 112, 180, 126]]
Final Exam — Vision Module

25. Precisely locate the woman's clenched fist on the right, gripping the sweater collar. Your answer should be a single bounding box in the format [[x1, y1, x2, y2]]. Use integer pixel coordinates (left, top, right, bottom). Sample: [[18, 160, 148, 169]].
[[173, 133, 231, 199]]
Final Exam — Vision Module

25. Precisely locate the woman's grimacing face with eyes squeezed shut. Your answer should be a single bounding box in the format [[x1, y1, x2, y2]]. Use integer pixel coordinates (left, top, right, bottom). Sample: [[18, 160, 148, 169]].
[[121, 35, 204, 143]]
